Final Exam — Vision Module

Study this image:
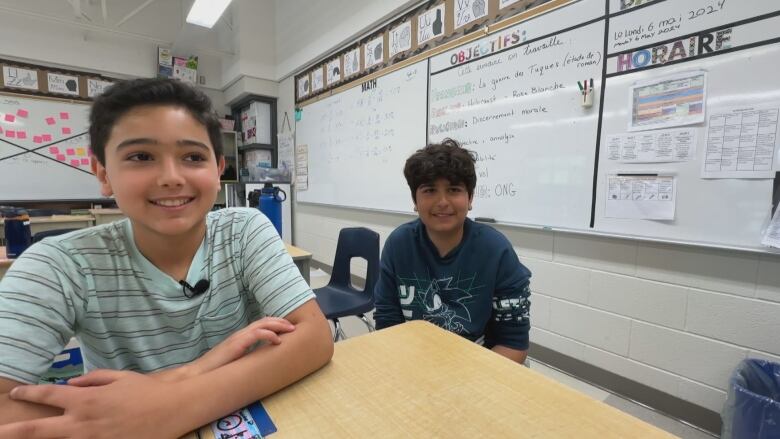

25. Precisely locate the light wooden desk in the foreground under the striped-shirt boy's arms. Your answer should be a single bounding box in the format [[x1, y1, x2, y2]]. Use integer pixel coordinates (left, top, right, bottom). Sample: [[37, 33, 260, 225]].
[[186, 321, 674, 439]]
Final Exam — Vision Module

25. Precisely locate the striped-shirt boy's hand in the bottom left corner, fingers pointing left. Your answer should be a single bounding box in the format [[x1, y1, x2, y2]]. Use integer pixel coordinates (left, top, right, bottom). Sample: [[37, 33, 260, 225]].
[[0, 370, 186, 439]]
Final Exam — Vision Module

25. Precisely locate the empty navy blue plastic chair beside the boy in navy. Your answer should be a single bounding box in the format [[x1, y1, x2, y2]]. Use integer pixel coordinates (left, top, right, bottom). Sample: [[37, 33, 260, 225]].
[[314, 227, 379, 341]]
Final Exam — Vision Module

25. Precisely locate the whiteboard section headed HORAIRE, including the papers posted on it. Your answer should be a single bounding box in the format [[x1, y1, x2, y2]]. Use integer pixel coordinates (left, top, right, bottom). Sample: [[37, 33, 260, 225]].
[[594, 0, 780, 247]]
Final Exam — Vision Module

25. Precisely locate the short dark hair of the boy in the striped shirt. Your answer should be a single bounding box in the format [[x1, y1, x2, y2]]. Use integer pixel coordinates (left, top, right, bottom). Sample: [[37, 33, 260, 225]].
[[89, 78, 222, 165]]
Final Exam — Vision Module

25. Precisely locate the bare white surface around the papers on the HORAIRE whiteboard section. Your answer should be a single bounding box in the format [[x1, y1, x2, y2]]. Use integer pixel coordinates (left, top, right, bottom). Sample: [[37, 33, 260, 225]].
[[594, 0, 780, 248]]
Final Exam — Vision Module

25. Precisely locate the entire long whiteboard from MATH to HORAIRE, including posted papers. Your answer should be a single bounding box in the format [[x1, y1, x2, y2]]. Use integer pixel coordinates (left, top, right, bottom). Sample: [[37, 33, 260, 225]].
[[297, 0, 780, 251]]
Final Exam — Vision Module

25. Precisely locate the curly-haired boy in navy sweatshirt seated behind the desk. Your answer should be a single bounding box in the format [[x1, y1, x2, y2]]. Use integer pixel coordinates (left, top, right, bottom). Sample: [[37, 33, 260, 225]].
[[374, 139, 531, 363]]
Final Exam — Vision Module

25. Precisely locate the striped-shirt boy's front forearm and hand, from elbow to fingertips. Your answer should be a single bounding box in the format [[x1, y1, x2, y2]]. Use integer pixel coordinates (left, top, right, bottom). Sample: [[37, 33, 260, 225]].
[[0, 300, 333, 438]]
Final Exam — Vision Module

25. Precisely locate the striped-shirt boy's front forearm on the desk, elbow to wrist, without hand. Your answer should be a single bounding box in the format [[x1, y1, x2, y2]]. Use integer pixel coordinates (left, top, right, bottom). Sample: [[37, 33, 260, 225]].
[[155, 304, 333, 430]]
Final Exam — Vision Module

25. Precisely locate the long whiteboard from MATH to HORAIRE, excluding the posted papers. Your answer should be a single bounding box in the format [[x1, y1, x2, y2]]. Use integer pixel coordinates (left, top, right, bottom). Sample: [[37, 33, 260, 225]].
[[290, 0, 780, 252]]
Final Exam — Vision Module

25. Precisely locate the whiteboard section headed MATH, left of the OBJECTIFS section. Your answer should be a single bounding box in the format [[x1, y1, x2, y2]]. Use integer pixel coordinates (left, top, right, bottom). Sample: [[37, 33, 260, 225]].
[[295, 60, 428, 213]]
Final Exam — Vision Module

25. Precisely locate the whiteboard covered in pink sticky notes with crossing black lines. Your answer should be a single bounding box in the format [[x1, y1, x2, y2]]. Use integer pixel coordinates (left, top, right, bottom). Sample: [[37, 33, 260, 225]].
[[0, 95, 103, 201]]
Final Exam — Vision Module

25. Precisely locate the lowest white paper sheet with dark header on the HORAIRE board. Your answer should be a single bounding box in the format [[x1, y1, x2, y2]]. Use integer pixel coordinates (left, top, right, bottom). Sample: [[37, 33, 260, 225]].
[[604, 174, 677, 220]]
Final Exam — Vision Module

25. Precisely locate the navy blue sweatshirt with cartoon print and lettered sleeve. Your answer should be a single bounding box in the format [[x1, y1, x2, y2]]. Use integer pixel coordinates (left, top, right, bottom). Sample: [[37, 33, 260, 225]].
[[374, 218, 531, 350]]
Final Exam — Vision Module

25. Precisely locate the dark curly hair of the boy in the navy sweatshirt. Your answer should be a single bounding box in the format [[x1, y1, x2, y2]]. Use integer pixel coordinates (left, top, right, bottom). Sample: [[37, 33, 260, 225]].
[[404, 138, 477, 203]]
